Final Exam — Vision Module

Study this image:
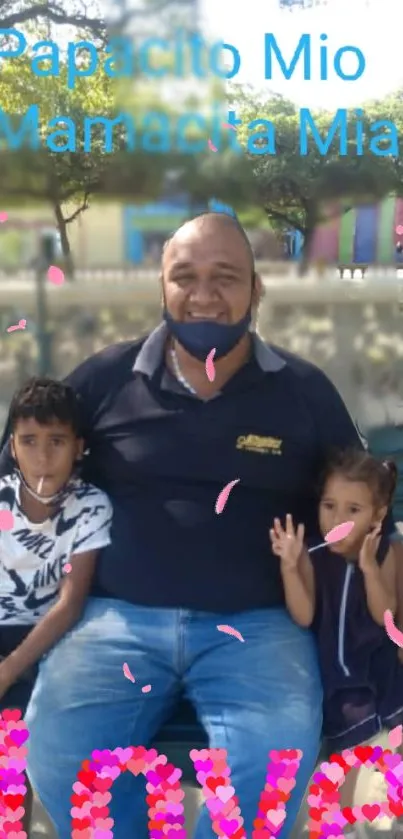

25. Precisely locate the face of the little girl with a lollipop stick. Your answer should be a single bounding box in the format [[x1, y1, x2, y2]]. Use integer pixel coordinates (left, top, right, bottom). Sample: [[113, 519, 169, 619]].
[[319, 474, 387, 557]]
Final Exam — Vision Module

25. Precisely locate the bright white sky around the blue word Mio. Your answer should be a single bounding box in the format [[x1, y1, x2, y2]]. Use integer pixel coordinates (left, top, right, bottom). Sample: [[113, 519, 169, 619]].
[[200, 0, 403, 109]]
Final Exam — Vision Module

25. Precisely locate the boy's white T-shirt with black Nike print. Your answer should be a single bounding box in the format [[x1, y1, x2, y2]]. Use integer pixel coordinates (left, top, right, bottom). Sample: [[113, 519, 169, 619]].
[[0, 474, 112, 626]]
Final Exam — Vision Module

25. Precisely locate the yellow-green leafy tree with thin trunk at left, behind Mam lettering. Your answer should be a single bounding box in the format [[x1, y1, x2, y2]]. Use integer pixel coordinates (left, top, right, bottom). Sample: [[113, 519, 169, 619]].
[[0, 44, 172, 272]]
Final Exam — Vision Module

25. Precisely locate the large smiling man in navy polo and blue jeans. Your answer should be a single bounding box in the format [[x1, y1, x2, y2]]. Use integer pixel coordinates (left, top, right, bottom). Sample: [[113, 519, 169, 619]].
[[3, 213, 396, 839]]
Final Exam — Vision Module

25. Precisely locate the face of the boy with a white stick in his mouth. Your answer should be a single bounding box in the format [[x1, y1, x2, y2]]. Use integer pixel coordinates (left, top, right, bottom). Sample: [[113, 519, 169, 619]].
[[11, 417, 83, 496]]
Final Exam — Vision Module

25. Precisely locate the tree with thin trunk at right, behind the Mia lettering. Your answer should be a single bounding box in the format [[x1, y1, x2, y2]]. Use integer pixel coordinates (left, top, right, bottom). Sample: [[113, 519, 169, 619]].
[[232, 89, 396, 271]]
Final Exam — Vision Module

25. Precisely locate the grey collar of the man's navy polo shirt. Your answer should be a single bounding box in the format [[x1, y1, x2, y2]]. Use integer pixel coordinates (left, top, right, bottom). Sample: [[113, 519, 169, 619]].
[[133, 323, 286, 377]]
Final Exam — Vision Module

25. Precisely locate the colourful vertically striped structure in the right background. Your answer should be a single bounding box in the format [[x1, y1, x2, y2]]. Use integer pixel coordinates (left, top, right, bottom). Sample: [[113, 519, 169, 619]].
[[310, 196, 403, 265]]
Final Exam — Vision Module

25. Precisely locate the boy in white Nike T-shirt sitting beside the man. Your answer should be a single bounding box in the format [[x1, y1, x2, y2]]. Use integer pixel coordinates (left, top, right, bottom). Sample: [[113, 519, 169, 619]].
[[0, 378, 112, 834]]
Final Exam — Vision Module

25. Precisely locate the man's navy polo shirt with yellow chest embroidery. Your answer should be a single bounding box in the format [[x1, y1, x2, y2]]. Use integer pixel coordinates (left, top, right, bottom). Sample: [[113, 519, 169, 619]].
[[0, 325, 394, 613]]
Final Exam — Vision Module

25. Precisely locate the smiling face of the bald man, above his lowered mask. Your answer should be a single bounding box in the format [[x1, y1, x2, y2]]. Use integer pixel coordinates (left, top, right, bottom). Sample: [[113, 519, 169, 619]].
[[162, 222, 261, 324]]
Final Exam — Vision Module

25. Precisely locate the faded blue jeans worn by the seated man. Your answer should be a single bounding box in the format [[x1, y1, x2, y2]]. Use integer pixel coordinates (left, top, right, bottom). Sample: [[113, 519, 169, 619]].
[[26, 598, 322, 839]]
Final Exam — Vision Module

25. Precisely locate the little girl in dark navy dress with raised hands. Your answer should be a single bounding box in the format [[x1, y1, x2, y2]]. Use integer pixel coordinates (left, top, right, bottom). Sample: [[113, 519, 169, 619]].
[[270, 450, 403, 839]]
